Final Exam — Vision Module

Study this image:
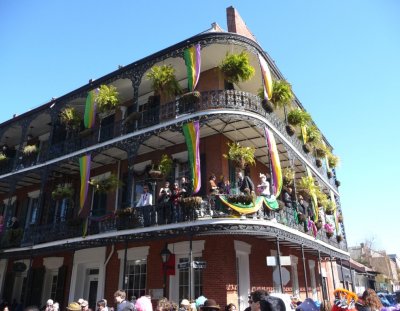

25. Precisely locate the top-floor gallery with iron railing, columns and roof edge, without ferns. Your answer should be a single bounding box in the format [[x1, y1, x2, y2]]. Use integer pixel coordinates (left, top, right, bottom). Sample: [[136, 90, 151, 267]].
[[0, 33, 336, 188]]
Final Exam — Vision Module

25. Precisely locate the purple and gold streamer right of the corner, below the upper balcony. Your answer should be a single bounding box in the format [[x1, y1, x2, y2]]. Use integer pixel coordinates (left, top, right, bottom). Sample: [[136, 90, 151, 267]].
[[264, 127, 283, 197]]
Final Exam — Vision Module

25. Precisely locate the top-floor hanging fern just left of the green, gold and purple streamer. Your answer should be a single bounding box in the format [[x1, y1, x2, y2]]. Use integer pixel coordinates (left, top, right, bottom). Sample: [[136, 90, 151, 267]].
[[146, 65, 182, 97]]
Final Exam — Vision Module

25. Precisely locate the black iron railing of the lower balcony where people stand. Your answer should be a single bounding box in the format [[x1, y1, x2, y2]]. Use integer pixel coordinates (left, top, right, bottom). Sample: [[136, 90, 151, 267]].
[[0, 196, 347, 250]]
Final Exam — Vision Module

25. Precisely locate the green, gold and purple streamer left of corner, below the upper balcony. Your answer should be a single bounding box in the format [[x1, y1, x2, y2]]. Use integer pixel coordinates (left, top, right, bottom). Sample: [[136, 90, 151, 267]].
[[183, 121, 201, 194]]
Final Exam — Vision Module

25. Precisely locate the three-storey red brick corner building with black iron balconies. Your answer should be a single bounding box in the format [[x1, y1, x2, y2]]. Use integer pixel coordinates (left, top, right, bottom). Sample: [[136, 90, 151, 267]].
[[0, 8, 353, 310]]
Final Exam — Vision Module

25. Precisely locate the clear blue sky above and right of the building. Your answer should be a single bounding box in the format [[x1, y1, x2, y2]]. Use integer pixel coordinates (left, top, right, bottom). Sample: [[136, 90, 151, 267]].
[[0, 0, 400, 255]]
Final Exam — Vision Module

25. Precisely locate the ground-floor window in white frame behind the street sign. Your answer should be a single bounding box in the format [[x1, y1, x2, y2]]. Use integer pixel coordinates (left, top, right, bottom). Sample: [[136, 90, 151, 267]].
[[178, 257, 203, 301]]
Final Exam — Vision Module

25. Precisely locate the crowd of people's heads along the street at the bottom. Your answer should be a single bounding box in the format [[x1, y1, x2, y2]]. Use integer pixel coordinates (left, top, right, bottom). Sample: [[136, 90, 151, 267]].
[[0, 288, 400, 311]]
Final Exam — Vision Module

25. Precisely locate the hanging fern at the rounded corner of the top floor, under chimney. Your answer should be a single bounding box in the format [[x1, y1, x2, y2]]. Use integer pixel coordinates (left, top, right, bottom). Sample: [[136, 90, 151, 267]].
[[219, 51, 255, 84]]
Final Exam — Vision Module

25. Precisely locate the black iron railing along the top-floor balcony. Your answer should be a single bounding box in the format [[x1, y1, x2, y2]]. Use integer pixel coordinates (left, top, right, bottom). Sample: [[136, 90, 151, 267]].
[[0, 90, 337, 188]]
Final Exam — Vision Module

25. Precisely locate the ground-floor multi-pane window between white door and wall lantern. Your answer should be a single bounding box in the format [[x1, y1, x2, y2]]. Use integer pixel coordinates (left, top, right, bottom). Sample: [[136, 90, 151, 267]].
[[126, 259, 147, 299]]
